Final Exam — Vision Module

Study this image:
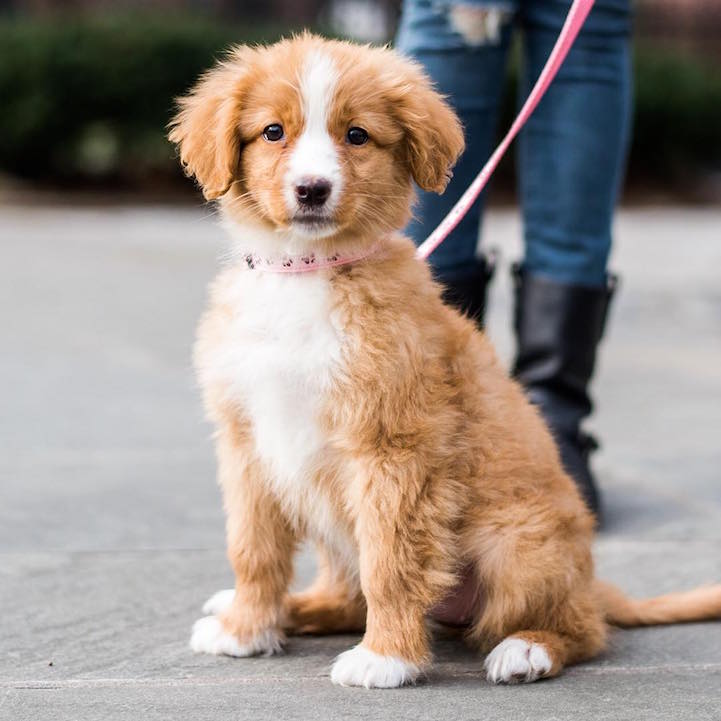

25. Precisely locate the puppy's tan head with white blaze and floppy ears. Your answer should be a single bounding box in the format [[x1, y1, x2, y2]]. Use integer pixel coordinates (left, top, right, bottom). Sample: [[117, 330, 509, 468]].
[[170, 34, 463, 248]]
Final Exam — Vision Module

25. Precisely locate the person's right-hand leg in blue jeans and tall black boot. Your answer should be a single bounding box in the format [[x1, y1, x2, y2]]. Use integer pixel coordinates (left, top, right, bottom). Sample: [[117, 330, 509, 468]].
[[514, 0, 631, 510]]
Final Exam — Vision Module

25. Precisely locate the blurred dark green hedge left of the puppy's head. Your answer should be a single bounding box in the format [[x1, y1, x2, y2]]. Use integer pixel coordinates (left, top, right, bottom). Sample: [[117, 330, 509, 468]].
[[0, 15, 279, 188]]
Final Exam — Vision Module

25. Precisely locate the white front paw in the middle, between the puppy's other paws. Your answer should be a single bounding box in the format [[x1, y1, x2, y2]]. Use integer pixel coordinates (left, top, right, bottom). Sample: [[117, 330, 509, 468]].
[[330, 645, 420, 688]]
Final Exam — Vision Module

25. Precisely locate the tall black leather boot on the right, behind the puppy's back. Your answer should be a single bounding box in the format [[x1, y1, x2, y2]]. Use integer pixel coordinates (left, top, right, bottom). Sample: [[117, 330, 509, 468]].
[[513, 266, 616, 519]]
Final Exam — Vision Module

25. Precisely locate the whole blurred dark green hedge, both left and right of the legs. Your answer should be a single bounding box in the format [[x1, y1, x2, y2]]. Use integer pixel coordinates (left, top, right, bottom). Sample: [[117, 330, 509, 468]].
[[0, 15, 721, 193]]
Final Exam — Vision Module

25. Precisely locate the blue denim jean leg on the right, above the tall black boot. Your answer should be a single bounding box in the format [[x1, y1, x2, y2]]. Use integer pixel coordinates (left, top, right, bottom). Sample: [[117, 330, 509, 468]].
[[519, 0, 631, 287]]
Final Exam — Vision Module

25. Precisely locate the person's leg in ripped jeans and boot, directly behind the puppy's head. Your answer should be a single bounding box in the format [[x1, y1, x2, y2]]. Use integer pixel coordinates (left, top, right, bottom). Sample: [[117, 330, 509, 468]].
[[396, 0, 515, 321]]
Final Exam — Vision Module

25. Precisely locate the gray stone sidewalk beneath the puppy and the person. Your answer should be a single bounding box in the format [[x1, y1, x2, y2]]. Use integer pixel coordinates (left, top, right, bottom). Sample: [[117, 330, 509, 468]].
[[0, 207, 721, 721]]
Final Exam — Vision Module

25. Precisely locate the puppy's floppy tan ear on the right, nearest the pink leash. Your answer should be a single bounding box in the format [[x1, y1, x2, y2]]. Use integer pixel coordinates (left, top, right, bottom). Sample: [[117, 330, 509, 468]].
[[394, 58, 465, 193]]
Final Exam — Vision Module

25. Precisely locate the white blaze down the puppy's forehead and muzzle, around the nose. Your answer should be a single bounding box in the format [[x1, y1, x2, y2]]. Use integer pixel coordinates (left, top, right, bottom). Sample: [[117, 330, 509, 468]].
[[284, 50, 343, 213]]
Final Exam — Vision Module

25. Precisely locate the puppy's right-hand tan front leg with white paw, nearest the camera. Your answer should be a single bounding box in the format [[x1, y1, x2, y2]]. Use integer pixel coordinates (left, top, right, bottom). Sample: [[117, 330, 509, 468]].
[[331, 460, 453, 688]]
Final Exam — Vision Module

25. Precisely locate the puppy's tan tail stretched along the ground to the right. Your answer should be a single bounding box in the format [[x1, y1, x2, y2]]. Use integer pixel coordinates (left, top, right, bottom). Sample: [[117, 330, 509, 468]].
[[596, 580, 721, 627]]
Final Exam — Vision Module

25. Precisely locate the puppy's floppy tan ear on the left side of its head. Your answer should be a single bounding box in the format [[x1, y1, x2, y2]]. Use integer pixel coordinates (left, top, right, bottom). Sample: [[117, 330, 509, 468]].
[[168, 47, 252, 200]]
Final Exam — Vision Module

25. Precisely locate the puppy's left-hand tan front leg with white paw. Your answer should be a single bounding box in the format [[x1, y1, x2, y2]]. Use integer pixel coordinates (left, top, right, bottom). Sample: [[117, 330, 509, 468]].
[[190, 426, 295, 656]]
